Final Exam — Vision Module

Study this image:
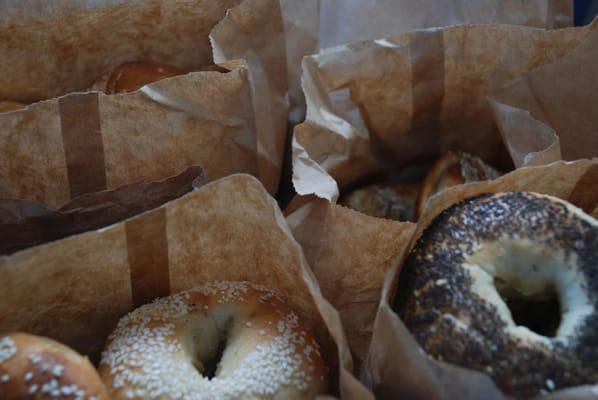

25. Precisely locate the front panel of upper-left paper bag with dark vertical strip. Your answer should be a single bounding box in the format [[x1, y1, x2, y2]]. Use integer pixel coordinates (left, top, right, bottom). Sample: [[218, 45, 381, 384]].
[[0, 63, 257, 208]]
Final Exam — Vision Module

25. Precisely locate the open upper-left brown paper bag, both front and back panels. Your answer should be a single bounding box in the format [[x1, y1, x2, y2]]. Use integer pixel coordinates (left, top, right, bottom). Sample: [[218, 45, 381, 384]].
[[0, 0, 286, 208]]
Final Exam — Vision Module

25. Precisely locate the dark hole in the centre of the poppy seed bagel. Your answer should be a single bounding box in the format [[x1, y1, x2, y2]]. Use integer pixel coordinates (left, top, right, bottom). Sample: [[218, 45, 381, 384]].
[[494, 278, 561, 338]]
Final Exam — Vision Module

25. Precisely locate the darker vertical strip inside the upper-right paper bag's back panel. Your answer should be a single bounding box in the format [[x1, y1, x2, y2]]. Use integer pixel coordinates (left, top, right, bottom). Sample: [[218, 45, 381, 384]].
[[409, 29, 444, 129]]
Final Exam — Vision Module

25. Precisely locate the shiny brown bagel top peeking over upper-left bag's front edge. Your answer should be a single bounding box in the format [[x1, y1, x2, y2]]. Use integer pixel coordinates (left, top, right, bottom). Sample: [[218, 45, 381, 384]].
[[106, 61, 184, 94]]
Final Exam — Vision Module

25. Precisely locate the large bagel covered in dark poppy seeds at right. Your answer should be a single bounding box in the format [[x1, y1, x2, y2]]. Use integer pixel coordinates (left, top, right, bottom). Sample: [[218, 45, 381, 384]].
[[394, 192, 598, 398]]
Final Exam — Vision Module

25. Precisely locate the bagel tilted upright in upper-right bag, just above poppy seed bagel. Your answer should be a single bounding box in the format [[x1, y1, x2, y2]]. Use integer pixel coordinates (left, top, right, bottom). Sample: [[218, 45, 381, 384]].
[[416, 151, 500, 217]]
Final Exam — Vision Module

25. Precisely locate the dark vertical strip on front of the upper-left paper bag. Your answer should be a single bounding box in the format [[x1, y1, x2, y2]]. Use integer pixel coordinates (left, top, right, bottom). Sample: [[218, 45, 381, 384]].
[[58, 93, 107, 199]]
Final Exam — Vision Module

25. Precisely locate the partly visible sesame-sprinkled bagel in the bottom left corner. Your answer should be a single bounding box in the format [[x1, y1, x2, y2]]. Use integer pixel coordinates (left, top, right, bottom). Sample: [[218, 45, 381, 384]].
[[0, 333, 109, 400]]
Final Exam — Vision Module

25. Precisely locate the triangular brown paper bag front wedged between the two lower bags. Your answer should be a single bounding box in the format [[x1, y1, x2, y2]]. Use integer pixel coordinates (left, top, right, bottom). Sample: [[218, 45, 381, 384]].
[[287, 199, 415, 363]]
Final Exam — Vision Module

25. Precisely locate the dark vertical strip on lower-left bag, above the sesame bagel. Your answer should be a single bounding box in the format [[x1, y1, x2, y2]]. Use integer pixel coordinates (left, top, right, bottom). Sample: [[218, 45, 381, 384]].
[[125, 207, 170, 307]]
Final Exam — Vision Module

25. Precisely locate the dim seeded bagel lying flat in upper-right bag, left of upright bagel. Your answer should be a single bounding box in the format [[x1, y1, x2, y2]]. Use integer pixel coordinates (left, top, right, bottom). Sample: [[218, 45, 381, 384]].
[[340, 183, 419, 221]]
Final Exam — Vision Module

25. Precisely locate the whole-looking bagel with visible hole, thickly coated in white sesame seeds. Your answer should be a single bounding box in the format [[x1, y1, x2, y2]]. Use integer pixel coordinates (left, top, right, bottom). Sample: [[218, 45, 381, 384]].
[[99, 282, 327, 400]]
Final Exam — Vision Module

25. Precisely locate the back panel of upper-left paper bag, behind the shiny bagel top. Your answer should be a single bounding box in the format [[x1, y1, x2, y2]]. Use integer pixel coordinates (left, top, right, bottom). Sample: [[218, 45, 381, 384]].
[[0, 0, 241, 102]]
